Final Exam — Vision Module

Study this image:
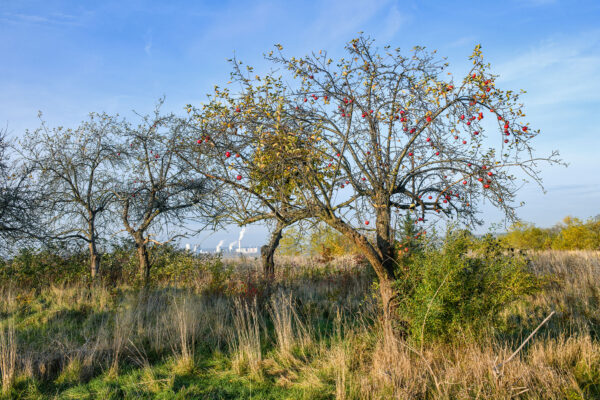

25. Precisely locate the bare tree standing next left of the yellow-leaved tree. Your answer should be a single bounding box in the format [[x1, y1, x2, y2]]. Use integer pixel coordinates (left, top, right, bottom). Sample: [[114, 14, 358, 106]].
[[113, 101, 214, 283]]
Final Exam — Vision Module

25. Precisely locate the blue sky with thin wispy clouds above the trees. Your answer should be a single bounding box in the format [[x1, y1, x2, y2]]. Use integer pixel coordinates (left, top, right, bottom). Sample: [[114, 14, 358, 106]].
[[0, 0, 600, 246]]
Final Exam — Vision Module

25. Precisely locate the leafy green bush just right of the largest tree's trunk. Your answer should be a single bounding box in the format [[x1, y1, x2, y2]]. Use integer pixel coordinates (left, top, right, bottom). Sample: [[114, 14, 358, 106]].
[[397, 232, 541, 341]]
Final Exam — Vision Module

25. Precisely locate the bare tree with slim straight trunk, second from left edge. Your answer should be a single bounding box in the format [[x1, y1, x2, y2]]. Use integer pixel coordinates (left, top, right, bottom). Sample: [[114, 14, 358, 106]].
[[21, 113, 118, 278]]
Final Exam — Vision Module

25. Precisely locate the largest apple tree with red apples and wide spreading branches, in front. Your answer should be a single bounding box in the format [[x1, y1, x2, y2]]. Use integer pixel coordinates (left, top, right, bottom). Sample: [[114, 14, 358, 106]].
[[199, 36, 558, 338]]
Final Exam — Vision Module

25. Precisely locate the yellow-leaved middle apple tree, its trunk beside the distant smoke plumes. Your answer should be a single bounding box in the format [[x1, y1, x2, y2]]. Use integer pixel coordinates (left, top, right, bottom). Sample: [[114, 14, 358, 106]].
[[182, 72, 346, 278]]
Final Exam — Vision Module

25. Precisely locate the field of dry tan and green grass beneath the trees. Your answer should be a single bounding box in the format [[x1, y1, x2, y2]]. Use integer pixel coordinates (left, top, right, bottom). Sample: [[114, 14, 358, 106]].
[[0, 251, 600, 399]]
